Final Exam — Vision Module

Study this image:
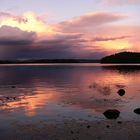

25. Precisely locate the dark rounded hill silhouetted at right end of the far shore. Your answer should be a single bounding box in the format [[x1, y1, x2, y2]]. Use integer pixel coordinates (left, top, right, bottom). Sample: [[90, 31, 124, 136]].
[[101, 52, 140, 64]]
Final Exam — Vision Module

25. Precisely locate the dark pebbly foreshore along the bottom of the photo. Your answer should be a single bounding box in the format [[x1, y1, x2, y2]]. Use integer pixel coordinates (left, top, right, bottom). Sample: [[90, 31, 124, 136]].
[[0, 120, 140, 140]]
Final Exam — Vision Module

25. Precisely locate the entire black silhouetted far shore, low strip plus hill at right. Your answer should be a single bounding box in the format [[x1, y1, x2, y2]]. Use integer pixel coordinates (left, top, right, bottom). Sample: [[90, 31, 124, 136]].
[[0, 52, 140, 64]]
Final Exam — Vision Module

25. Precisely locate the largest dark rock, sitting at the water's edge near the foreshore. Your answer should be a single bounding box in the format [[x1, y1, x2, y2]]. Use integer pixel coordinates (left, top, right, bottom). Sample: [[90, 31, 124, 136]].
[[103, 109, 120, 119]]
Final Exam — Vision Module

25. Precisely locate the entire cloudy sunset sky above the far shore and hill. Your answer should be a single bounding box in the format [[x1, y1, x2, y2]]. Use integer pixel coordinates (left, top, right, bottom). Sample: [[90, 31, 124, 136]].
[[0, 0, 140, 59]]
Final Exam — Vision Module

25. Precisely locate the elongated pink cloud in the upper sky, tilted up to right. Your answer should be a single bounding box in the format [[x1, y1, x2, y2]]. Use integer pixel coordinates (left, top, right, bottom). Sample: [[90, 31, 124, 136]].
[[56, 12, 127, 32]]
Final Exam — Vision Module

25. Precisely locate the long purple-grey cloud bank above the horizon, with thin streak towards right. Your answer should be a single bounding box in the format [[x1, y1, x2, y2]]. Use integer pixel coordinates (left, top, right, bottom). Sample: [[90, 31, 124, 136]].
[[0, 26, 127, 59]]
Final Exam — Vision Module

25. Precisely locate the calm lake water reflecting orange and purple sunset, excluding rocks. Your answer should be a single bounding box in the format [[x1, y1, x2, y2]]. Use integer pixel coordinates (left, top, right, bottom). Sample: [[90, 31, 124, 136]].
[[0, 64, 140, 129]]
